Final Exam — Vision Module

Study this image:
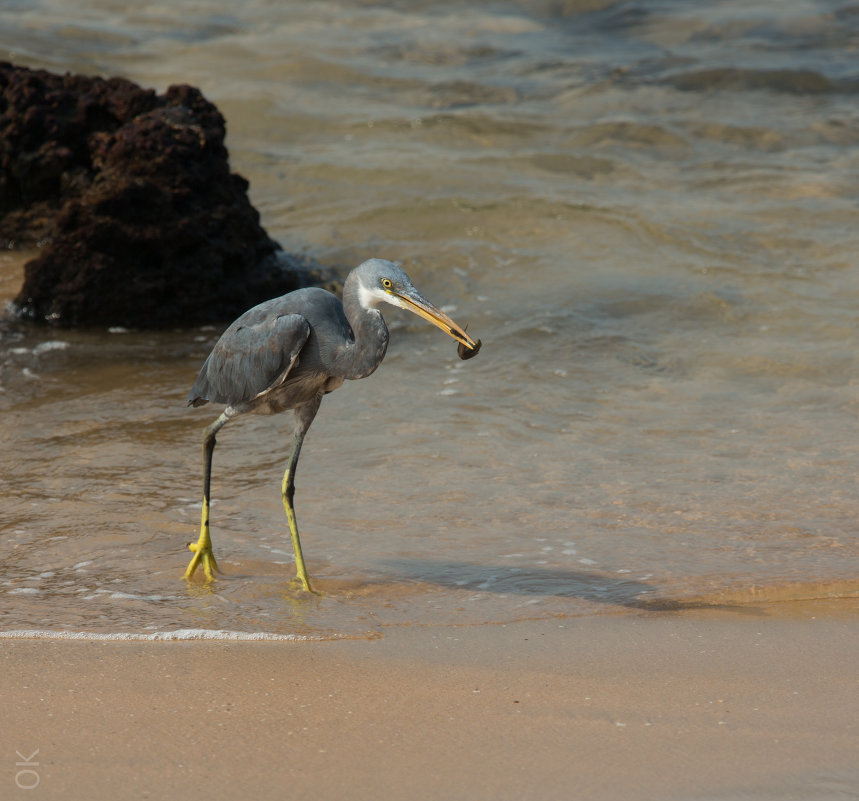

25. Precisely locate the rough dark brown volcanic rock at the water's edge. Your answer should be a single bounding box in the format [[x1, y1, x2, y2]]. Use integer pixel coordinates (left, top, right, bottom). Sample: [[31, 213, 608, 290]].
[[0, 62, 306, 328]]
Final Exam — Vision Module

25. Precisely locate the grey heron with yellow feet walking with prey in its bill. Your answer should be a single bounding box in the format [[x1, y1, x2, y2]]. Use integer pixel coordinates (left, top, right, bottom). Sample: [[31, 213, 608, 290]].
[[185, 259, 480, 593]]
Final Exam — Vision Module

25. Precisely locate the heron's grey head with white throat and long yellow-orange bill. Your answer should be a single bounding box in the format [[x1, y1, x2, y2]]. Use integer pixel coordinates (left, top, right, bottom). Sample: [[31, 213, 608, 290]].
[[353, 259, 478, 351]]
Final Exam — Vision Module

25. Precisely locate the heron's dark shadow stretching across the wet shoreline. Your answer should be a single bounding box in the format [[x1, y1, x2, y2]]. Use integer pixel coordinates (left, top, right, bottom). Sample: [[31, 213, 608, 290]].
[[384, 558, 740, 612]]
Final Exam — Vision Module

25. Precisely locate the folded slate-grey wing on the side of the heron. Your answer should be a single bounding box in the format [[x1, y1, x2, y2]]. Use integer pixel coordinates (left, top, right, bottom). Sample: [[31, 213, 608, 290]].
[[188, 314, 310, 406]]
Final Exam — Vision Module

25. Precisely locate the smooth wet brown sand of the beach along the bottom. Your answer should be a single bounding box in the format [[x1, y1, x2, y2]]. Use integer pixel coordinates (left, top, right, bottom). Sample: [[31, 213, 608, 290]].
[[0, 601, 859, 801]]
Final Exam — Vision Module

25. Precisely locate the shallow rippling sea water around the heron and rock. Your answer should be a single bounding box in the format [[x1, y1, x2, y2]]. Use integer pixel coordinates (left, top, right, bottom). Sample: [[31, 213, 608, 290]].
[[0, 0, 859, 636]]
